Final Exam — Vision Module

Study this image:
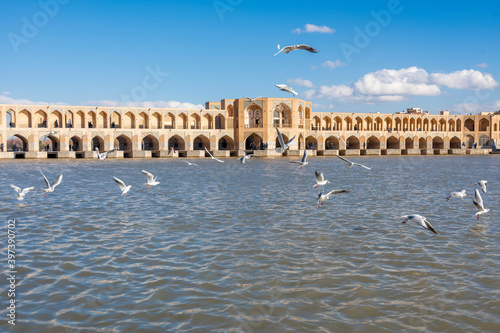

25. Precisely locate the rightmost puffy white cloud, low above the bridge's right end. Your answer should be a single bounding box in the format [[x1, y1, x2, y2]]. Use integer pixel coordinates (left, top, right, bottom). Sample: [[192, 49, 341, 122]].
[[429, 69, 498, 90]]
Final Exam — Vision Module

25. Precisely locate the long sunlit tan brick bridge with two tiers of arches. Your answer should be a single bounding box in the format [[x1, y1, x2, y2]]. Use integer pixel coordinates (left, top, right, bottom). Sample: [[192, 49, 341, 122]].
[[0, 98, 500, 158]]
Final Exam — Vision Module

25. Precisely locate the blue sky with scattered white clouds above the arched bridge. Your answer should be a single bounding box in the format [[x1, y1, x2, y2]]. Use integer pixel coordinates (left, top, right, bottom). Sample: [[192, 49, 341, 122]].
[[0, 0, 500, 113]]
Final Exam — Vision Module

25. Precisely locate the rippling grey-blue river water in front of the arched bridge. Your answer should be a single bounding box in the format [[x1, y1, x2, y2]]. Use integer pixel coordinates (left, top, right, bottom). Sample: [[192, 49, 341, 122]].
[[0, 156, 500, 332]]
